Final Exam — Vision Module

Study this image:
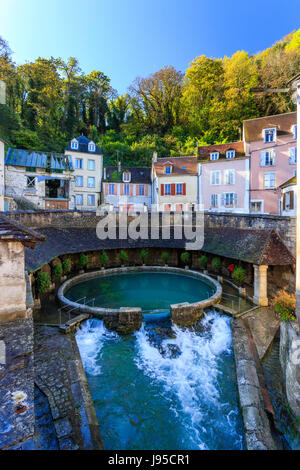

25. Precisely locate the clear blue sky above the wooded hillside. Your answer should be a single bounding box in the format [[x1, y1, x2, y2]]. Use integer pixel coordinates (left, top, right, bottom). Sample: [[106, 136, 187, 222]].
[[0, 0, 300, 94]]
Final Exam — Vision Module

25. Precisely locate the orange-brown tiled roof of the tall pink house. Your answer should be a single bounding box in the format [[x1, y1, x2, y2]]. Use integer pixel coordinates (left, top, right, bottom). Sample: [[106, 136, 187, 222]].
[[243, 112, 297, 142]]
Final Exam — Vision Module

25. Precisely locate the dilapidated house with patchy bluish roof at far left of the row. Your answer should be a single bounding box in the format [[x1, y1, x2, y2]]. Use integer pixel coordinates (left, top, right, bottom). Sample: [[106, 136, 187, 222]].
[[5, 148, 74, 209]]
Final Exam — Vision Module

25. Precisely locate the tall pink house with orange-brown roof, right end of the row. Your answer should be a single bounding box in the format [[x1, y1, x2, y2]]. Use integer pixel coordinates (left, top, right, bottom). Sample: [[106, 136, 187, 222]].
[[243, 112, 297, 214]]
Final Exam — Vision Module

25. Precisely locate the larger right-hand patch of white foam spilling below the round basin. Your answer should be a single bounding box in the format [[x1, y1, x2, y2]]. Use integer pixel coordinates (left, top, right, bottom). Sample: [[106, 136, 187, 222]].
[[136, 312, 238, 449]]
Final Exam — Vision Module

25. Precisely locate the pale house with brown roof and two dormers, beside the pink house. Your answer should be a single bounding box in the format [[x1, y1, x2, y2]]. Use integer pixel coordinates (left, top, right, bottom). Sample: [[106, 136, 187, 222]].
[[198, 142, 250, 213]]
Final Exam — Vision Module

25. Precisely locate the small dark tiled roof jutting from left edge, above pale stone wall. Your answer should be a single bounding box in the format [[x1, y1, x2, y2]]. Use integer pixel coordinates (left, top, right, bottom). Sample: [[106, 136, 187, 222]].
[[0, 213, 46, 248]]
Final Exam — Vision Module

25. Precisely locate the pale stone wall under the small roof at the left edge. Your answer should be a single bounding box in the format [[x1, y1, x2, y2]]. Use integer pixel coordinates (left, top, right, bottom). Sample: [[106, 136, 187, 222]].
[[0, 240, 26, 322]]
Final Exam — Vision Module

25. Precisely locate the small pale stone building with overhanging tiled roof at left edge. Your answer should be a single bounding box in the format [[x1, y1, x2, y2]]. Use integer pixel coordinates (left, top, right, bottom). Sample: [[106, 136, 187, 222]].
[[0, 214, 45, 323]]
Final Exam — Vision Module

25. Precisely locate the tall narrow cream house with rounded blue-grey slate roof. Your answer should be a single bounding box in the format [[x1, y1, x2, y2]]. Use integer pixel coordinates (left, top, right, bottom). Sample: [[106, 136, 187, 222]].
[[65, 135, 103, 210]]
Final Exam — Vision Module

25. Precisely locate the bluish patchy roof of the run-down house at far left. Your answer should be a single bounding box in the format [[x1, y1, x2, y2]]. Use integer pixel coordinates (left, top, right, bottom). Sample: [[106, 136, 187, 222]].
[[5, 148, 73, 171]]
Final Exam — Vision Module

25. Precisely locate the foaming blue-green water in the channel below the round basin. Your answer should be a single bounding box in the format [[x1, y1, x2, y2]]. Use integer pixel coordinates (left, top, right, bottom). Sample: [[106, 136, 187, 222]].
[[76, 314, 244, 450]]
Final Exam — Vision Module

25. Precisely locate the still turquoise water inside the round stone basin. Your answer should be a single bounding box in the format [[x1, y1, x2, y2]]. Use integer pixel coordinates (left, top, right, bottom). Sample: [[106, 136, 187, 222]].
[[65, 271, 215, 311]]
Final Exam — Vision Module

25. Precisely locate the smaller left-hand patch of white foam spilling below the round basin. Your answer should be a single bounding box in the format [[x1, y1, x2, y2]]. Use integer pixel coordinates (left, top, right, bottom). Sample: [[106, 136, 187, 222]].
[[76, 319, 119, 375]]
